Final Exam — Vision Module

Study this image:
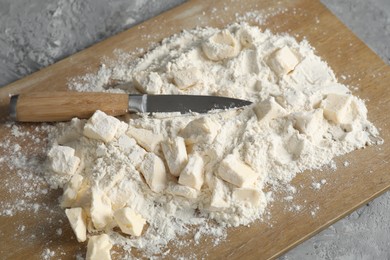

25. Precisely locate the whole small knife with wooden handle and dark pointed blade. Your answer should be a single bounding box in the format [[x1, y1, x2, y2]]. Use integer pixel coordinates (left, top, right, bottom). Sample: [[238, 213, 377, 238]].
[[10, 92, 251, 122]]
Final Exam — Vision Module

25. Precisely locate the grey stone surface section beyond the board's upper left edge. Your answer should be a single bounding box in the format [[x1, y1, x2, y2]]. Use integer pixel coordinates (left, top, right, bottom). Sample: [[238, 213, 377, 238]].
[[0, 0, 184, 86]]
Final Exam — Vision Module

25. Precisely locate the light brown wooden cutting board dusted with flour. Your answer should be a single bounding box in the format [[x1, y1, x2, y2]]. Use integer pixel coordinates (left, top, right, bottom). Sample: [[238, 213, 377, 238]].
[[0, 0, 390, 259]]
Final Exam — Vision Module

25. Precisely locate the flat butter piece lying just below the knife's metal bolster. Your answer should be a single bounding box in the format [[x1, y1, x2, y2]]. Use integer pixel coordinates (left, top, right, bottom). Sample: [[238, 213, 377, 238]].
[[126, 126, 163, 152]]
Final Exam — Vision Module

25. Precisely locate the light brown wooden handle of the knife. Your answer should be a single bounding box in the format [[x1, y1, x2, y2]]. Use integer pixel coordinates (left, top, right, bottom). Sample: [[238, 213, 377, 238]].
[[10, 92, 129, 122]]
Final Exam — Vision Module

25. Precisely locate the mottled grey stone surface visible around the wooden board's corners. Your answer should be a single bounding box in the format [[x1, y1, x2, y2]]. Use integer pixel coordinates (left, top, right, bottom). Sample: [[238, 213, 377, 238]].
[[0, 0, 390, 260]]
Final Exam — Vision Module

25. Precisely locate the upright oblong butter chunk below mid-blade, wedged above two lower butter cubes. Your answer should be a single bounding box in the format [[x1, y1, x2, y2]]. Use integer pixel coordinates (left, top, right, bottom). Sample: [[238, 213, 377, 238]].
[[161, 137, 187, 176]]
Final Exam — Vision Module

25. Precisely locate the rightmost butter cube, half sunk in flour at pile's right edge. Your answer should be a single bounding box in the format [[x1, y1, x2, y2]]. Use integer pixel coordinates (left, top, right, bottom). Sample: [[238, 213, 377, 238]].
[[320, 94, 353, 124]]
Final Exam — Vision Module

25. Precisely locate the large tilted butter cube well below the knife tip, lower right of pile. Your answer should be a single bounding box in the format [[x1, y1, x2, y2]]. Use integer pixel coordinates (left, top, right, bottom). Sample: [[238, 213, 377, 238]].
[[217, 154, 259, 187]]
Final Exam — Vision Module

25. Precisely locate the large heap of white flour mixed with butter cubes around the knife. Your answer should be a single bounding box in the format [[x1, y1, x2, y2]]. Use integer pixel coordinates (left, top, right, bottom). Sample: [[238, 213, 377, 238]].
[[46, 23, 378, 256]]
